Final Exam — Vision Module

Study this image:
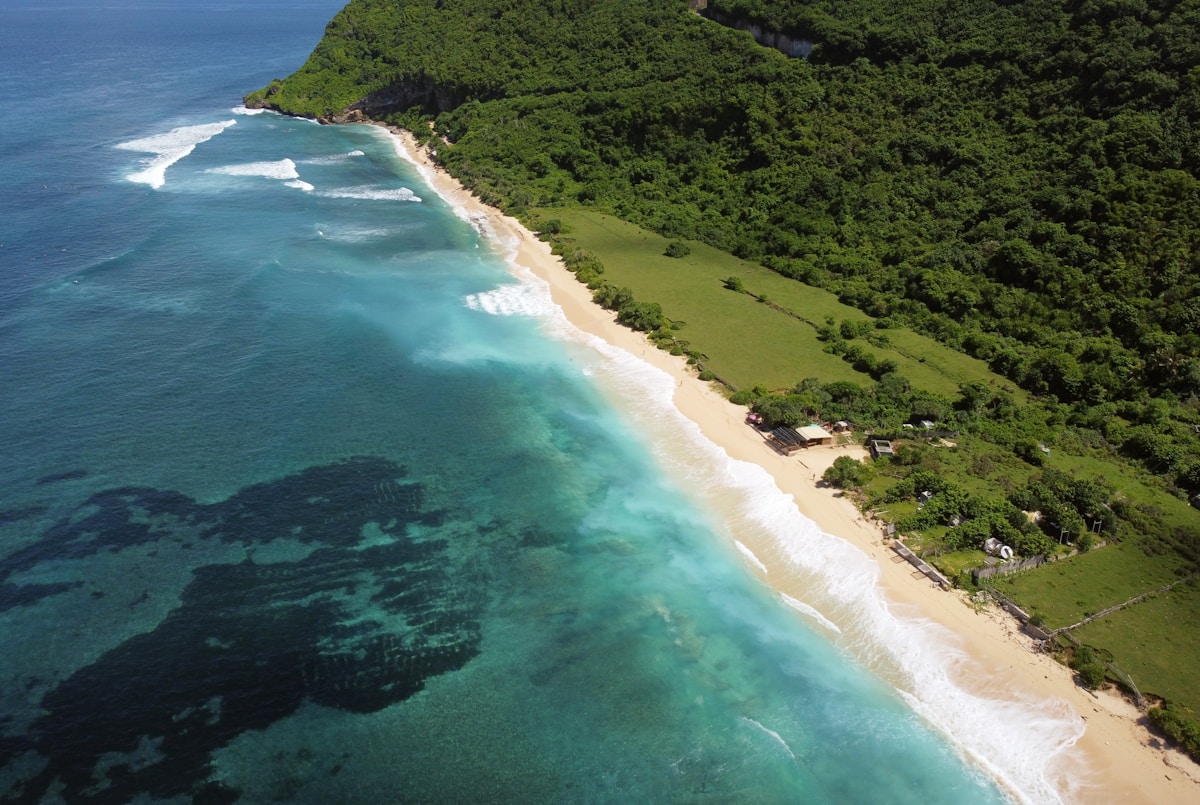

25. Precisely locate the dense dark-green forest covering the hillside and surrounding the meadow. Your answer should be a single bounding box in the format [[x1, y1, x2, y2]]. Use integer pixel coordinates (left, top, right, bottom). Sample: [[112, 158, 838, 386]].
[[247, 0, 1200, 752]]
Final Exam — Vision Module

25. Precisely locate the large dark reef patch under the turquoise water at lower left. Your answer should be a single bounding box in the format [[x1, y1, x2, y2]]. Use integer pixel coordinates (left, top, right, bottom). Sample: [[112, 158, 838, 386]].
[[0, 457, 481, 803]]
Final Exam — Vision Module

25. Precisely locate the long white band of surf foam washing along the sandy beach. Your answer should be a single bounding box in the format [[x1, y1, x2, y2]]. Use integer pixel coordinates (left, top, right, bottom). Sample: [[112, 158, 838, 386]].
[[484, 253, 1085, 803]]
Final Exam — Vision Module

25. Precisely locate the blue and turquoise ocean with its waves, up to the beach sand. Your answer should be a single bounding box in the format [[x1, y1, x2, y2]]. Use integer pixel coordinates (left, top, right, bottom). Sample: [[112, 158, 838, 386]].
[[0, 0, 1078, 805]]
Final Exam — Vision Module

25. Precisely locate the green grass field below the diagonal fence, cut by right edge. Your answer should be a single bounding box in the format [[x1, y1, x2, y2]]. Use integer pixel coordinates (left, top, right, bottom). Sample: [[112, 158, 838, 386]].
[[1074, 583, 1200, 703]]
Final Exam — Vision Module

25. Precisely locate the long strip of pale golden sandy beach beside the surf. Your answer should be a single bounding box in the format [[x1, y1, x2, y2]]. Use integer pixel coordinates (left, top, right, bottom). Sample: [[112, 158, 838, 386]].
[[392, 125, 1200, 805]]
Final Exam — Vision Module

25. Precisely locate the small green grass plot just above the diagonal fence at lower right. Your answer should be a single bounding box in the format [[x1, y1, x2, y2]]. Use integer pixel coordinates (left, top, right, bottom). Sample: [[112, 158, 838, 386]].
[[995, 542, 1194, 628]]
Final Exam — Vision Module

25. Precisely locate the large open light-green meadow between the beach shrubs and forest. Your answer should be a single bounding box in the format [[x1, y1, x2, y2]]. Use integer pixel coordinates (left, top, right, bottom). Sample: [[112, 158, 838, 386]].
[[540, 209, 1010, 396]]
